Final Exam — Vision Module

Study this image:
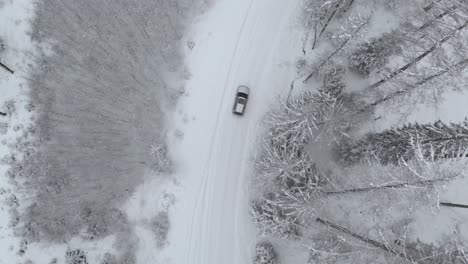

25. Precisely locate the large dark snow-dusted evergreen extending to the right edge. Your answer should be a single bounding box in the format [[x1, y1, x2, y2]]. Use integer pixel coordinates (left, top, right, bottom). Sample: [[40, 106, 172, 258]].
[[337, 119, 468, 165]]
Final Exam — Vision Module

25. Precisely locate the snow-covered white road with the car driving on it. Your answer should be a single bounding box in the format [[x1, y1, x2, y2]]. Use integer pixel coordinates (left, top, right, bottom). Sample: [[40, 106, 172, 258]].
[[163, 0, 300, 264]]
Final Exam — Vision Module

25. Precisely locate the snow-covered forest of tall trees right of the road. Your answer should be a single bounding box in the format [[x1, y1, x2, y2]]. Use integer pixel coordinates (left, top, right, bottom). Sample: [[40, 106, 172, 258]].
[[251, 0, 468, 264]]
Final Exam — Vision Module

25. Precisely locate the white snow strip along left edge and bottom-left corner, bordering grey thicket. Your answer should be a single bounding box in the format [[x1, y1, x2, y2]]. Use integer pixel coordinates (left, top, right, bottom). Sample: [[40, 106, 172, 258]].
[[0, 0, 118, 264]]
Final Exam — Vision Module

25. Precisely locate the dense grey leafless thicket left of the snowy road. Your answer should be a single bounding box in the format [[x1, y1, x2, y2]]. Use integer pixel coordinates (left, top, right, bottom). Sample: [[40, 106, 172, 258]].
[[0, 0, 208, 263]]
